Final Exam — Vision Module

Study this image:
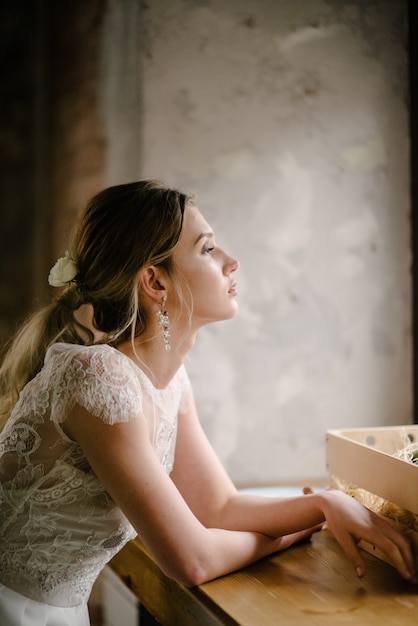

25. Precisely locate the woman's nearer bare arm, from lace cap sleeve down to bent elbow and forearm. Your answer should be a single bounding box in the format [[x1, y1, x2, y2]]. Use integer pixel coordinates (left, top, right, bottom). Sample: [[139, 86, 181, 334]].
[[65, 407, 306, 585]]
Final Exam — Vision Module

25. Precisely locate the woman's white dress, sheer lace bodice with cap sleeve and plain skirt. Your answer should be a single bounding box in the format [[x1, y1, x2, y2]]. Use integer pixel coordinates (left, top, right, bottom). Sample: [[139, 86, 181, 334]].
[[0, 343, 189, 626]]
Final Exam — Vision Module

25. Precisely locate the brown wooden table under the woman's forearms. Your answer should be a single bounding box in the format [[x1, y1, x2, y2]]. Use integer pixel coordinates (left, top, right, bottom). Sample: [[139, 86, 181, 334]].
[[110, 530, 418, 626]]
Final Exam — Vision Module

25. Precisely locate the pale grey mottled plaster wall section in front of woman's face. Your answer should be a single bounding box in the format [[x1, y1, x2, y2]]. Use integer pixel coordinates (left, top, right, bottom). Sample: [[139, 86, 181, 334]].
[[105, 0, 412, 482]]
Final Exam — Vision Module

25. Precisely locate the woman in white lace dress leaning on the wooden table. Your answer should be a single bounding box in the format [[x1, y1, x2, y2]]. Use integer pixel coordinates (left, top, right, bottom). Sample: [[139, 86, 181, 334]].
[[0, 181, 415, 626]]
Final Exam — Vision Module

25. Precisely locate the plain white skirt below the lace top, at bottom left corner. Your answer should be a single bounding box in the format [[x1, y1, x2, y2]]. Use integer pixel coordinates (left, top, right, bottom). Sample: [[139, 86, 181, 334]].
[[0, 583, 90, 626]]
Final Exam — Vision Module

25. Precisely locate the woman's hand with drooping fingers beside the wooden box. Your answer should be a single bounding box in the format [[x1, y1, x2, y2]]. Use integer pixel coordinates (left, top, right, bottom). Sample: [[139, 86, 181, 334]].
[[323, 491, 417, 582]]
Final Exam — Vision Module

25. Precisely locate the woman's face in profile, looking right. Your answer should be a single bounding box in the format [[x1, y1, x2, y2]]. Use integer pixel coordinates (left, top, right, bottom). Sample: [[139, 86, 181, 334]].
[[173, 205, 239, 326]]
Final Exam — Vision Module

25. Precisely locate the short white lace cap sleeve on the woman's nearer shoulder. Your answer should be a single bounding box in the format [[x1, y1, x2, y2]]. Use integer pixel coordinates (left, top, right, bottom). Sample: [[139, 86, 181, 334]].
[[49, 345, 142, 424]]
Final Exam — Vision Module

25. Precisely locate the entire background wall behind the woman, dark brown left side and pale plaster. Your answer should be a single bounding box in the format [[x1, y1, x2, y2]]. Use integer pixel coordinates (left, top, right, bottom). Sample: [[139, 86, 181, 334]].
[[0, 0, 412, 482]]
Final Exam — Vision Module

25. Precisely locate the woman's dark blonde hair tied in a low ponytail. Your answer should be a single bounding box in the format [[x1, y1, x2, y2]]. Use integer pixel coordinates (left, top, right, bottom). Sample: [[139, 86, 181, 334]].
[[0, 181, 193, 429]]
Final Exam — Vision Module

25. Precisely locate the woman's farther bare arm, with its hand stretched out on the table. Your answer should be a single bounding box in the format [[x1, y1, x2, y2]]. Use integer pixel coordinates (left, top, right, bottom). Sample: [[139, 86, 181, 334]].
[[172, 386, 415, 578]]
